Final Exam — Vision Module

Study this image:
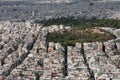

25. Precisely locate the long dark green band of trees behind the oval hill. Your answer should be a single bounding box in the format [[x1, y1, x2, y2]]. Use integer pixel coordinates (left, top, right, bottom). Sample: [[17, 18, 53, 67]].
[[35, 17, 120, 28]]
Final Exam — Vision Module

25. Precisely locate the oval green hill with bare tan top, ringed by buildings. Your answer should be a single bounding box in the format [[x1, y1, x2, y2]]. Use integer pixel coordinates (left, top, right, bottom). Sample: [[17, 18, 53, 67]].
[[47, 27, 116, 46]]
